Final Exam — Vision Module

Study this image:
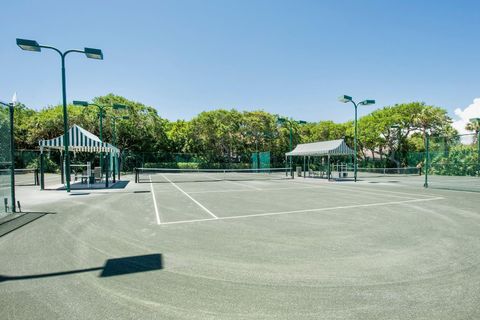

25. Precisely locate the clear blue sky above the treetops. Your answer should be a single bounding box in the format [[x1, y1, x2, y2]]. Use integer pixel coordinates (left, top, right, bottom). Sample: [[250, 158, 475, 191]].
[[0, 0, 480, 125]]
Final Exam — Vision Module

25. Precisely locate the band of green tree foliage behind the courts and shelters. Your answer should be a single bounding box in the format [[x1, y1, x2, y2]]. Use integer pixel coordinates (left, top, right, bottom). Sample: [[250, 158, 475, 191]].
[[5, 94, 464, 170]]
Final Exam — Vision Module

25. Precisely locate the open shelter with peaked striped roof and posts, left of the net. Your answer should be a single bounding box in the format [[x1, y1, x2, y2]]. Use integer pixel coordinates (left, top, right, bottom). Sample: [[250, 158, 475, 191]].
[[38, 124, 120, 189]]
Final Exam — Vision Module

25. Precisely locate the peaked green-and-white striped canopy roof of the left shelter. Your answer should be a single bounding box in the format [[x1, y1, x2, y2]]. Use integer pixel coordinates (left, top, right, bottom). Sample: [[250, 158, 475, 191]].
[[38, 124, 120, 154]]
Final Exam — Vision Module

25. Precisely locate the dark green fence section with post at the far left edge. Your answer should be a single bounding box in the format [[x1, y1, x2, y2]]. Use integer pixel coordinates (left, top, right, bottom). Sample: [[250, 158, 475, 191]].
[[0, 109, 12, 217]]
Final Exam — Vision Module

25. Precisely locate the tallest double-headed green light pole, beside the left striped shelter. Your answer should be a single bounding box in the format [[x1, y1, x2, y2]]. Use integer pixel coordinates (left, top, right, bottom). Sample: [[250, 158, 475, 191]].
[[17, 38, 103, 192]]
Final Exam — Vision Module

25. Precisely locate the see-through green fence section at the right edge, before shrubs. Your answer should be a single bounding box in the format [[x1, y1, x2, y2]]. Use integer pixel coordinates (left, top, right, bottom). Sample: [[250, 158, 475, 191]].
[[426, 134, 480, 192]]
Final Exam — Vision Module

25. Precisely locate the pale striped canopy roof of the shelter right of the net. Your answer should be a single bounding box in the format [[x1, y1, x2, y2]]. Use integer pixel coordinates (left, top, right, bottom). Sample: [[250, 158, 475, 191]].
[[285, 139, 353, 156]]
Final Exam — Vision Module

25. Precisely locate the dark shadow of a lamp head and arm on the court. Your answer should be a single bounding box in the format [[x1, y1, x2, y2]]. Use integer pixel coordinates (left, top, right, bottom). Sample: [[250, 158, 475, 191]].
[[0, 253, 163, 282]]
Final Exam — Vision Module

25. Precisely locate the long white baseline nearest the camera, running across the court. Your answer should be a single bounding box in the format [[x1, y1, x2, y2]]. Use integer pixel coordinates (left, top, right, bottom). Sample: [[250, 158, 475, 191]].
[[162, 197, 445, 225]]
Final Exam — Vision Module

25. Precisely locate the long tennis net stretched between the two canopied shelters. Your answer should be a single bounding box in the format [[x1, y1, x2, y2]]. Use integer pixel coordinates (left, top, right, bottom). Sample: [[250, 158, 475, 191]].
[[135, 168, 293, 183]]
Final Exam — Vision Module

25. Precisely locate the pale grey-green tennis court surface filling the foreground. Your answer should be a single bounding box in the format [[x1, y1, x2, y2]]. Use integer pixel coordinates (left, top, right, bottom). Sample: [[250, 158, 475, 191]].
[[0, 177, 480, 320]]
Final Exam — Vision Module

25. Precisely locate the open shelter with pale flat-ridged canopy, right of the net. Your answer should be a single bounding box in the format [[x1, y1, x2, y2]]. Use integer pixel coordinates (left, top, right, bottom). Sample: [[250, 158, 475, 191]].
[[285, 139, 354, 179]]
